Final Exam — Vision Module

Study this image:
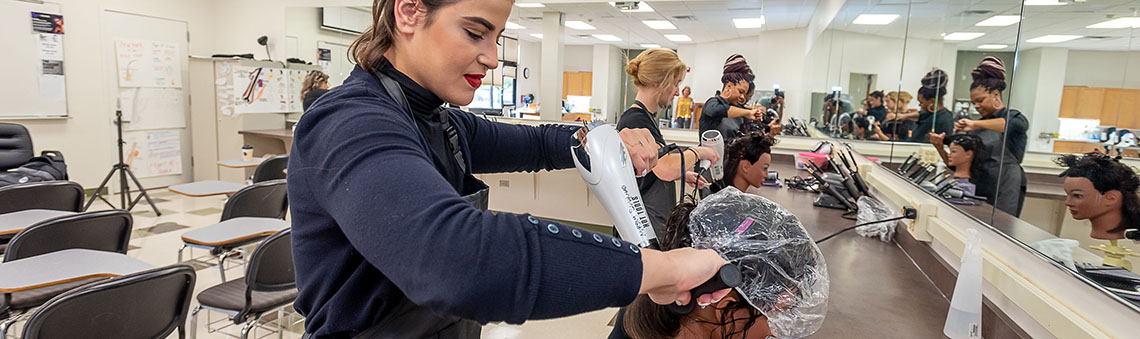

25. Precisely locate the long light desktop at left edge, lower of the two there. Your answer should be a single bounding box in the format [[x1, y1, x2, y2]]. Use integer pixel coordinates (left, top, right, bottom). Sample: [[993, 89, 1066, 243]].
[[0, 249, 154, 293]]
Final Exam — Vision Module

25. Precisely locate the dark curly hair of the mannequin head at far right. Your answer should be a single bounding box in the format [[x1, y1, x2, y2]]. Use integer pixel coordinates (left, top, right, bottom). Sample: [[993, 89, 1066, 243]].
[[1053, 153, 1140, 233]]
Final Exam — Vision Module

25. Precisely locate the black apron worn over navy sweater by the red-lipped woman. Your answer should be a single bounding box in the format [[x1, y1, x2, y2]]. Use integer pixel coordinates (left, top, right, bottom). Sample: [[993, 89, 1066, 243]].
[[312, 68, 489, 339]]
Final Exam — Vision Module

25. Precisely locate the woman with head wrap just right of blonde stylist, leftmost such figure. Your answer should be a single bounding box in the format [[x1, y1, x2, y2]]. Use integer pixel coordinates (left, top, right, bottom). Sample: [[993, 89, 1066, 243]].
[[700, 54, 765, 142]]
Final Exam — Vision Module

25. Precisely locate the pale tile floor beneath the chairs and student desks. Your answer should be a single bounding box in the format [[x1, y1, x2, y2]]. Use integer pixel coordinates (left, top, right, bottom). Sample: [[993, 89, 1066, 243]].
[[9, 188, 617, 339]]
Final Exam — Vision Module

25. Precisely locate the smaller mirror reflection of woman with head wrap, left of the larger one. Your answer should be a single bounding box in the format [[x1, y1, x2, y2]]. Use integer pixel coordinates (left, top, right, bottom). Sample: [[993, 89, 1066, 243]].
[[896, 68, 954, 143]]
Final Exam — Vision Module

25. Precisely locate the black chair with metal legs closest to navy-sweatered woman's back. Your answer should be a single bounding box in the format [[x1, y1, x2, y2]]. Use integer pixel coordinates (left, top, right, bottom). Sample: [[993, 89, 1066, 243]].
[[190, 229, 296, 339]]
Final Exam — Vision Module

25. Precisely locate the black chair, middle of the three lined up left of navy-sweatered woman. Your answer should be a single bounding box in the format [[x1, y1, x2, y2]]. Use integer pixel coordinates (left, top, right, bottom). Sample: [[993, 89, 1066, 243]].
[[178, 179, 288, 281]]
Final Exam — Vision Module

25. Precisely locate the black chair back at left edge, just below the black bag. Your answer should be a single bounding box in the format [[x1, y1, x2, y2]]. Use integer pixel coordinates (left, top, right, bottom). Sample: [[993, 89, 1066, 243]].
[[0, 180, 83, 215]]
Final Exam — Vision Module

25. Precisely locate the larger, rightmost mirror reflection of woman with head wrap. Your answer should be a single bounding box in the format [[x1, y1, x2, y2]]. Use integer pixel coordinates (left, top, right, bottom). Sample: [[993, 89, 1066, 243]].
[[957, 56, 1029, 213]]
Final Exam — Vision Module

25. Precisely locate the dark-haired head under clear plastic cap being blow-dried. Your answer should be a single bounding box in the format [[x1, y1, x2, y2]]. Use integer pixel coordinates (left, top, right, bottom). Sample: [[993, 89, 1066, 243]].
[[622, 187, 829, 339]]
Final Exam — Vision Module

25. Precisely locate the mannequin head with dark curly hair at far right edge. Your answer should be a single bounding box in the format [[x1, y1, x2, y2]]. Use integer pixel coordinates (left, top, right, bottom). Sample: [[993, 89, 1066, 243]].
[[1055, 153, 1140, 240]]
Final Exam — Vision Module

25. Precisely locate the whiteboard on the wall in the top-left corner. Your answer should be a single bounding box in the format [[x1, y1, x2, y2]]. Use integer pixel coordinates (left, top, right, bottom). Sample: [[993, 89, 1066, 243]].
[[0, 0, 67, 119]]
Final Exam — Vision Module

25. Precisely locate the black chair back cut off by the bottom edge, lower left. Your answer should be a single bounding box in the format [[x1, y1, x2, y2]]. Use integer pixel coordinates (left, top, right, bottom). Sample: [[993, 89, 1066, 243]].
[[24, 265, 195, 339]]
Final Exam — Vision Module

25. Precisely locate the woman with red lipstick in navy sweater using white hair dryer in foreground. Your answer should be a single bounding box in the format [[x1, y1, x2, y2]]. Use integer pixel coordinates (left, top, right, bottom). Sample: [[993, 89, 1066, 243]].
[[288, 0, 727, 338]]
